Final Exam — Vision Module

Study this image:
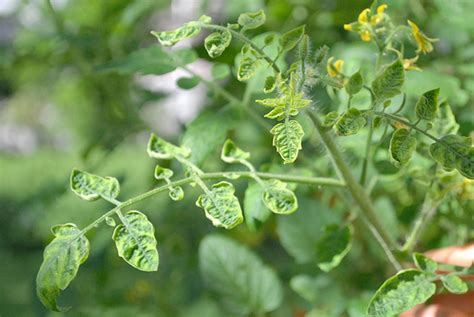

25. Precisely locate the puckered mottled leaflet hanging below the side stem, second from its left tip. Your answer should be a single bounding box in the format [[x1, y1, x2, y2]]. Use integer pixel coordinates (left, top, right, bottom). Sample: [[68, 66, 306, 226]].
[[112, 210, 159, 272]]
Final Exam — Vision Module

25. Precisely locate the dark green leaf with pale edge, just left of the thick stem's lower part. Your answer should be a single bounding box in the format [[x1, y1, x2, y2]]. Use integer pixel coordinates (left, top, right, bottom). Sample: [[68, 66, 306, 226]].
[[316, 224, 354, 272]]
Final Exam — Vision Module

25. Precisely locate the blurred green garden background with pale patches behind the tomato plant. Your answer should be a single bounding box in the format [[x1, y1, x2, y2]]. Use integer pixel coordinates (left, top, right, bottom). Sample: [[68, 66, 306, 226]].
[[0, 0, 474, 317]]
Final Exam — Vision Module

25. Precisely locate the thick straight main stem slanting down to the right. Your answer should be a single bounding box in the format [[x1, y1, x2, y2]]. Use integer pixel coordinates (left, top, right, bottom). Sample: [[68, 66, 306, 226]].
[[309, 113, 402, 270]]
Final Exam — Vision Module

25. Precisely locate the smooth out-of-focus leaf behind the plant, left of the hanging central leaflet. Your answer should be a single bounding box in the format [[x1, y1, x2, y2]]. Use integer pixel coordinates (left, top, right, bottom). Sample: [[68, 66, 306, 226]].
[[182, 109, 237, 165]]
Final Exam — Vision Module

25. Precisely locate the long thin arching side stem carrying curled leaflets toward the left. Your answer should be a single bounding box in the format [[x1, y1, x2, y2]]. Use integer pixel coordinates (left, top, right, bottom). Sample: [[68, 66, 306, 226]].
[[79, 171, 345, 236]]
